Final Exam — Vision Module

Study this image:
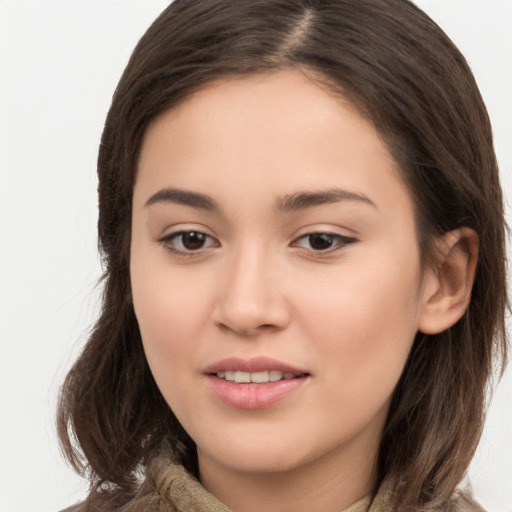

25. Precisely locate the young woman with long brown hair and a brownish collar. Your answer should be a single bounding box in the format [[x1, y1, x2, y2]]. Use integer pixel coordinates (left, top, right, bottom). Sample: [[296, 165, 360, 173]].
[[59, 0, 507, 512]]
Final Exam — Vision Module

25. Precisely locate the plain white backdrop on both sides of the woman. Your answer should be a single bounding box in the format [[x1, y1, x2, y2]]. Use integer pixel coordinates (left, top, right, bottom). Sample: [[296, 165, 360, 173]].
[[0, 0, 512, 512]]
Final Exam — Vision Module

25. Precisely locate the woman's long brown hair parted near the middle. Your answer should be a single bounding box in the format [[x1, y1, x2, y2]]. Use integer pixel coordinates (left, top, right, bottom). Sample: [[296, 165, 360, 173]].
[[58, 0, 507, 510]]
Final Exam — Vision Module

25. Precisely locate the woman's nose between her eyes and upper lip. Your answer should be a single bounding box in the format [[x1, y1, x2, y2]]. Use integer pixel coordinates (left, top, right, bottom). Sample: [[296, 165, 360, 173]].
[[214, 248, 290, 337]]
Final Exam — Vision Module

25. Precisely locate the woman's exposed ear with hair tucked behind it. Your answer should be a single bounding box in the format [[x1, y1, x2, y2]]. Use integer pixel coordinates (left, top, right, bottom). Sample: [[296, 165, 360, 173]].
[[418, 227, 478, 334]]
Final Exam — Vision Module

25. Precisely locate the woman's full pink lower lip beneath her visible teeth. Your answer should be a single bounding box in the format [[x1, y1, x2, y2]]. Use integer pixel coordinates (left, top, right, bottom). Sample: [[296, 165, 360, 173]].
[[207, 375, 307, 409]]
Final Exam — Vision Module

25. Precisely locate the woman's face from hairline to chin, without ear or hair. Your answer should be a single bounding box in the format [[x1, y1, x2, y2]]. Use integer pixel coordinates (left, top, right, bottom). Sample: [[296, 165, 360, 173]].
[[131, 71, 424, 480]]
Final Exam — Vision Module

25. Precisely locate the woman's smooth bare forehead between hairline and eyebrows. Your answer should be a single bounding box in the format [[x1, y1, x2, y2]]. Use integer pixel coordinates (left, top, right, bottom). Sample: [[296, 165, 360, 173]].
[[135, 71, 408, 220]]
